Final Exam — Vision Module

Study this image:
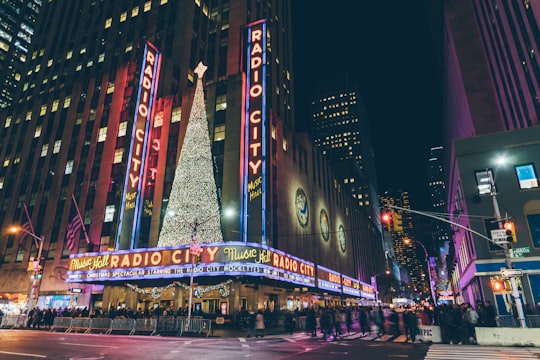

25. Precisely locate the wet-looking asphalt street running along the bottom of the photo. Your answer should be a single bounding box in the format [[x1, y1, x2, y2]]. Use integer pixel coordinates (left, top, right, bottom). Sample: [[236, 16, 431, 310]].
[[0, 329, 540, 360]]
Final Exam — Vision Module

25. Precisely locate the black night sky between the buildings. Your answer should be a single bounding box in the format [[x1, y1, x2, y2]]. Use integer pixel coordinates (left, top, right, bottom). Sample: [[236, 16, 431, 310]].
[[293, 0, 442, 210]]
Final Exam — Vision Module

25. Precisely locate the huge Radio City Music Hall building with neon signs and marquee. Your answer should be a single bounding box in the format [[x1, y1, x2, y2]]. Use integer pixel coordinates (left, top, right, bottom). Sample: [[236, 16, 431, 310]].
[[0, 0, 384, 314]]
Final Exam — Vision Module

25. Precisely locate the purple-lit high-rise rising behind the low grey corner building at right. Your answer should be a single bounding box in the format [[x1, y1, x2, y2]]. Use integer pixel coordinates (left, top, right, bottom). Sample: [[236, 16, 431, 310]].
[[438, 0, 540, 310]]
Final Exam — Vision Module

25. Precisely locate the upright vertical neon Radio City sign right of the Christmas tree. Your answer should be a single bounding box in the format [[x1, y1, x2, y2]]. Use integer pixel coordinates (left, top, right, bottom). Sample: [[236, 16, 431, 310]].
[[240, 20, 267, 244]]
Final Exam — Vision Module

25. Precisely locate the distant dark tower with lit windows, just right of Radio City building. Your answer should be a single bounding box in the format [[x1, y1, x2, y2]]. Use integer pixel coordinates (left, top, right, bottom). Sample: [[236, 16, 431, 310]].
[[310, 74, 380, 224]]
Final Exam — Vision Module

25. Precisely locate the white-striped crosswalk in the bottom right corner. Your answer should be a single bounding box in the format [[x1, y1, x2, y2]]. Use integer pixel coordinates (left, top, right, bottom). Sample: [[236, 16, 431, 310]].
[[424, 344, 540, 360]]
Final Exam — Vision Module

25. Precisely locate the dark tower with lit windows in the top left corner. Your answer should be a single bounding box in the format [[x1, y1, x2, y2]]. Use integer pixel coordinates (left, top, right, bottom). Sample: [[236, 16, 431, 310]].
[[0, 0, 42, 108]]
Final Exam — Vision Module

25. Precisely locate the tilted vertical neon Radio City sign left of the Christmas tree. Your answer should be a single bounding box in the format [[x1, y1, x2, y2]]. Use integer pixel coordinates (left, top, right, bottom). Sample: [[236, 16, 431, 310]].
[[116, 42, 161, 250]]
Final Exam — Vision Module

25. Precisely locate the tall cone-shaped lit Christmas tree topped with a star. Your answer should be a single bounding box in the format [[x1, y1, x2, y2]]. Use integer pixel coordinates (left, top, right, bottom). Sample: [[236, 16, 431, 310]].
[[158, 62, 223, 247]]
